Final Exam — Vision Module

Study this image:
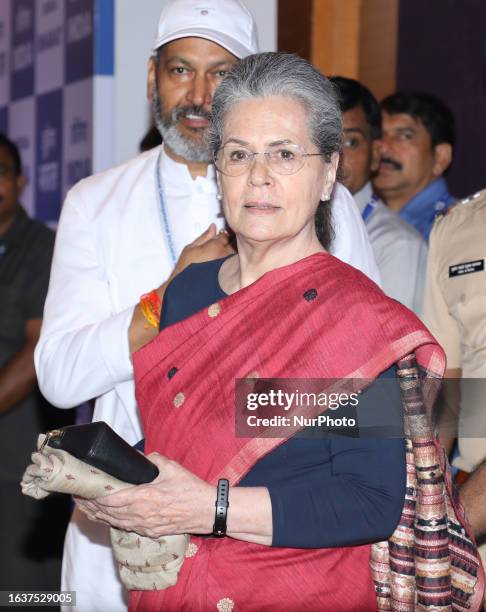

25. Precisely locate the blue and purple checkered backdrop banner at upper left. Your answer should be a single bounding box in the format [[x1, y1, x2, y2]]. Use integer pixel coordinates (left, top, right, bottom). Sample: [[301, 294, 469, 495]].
[[0, 0, 114, 225]]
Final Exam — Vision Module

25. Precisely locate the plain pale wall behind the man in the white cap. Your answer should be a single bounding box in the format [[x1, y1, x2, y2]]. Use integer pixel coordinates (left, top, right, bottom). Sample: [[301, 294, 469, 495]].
[[113, 0, 277, 164]]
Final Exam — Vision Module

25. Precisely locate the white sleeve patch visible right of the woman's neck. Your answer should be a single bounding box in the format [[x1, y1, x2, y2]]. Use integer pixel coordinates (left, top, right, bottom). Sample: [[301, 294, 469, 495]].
[[330, 183, 381, 286]]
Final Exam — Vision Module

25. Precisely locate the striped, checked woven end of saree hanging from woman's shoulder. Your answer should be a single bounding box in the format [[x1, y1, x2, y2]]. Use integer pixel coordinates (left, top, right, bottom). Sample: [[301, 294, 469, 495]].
[[370, 355, 482, 612]]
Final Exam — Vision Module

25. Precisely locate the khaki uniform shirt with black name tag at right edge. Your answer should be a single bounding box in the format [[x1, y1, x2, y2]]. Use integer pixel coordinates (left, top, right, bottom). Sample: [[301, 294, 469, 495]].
[[423, 189, 486, 472]]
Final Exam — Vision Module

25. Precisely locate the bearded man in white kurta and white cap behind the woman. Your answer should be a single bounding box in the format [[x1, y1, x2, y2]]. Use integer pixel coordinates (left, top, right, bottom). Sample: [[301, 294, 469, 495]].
[[35, 0, 378, 612]]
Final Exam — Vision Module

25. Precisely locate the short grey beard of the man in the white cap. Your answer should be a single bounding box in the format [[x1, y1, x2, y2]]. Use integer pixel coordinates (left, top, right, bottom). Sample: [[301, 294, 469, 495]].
[[152, 85, 211, 164]]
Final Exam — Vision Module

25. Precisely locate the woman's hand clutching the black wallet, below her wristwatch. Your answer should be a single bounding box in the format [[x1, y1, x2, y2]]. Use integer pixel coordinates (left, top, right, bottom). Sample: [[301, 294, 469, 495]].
[[76, 453, 216, 538]]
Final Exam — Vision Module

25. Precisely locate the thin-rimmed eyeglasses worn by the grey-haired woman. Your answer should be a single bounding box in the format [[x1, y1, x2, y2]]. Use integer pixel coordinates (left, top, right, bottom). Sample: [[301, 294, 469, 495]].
[[214, 143, 321, 176]]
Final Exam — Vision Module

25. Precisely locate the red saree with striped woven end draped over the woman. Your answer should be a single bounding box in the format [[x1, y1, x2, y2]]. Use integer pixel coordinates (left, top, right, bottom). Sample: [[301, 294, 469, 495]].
[[130, 253, 484, 612]]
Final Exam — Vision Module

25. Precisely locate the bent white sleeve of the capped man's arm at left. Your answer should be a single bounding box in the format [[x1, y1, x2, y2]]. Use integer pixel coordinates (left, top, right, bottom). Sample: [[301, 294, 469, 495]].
[[34, 186, 134, 408]]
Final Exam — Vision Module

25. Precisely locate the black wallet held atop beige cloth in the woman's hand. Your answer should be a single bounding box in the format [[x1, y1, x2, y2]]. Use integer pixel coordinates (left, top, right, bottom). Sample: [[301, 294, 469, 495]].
[[41, 421, 159, 484]]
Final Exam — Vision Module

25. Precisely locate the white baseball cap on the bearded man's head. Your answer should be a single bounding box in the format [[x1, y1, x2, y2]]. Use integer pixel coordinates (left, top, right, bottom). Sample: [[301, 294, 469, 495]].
[[154, 0, 258, 59]]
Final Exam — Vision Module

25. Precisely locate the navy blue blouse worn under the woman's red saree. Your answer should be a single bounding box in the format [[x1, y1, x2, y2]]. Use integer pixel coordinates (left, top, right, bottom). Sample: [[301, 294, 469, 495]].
[[160, 259, 406, 548]]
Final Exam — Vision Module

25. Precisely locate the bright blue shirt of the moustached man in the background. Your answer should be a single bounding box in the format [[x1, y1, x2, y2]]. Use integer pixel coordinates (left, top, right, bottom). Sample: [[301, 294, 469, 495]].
[[398, 177, 456, 241]]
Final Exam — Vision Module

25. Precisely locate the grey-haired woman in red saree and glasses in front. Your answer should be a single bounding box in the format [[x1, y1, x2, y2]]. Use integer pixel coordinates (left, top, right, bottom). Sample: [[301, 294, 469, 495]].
[[81, 53, 480, 611]]
